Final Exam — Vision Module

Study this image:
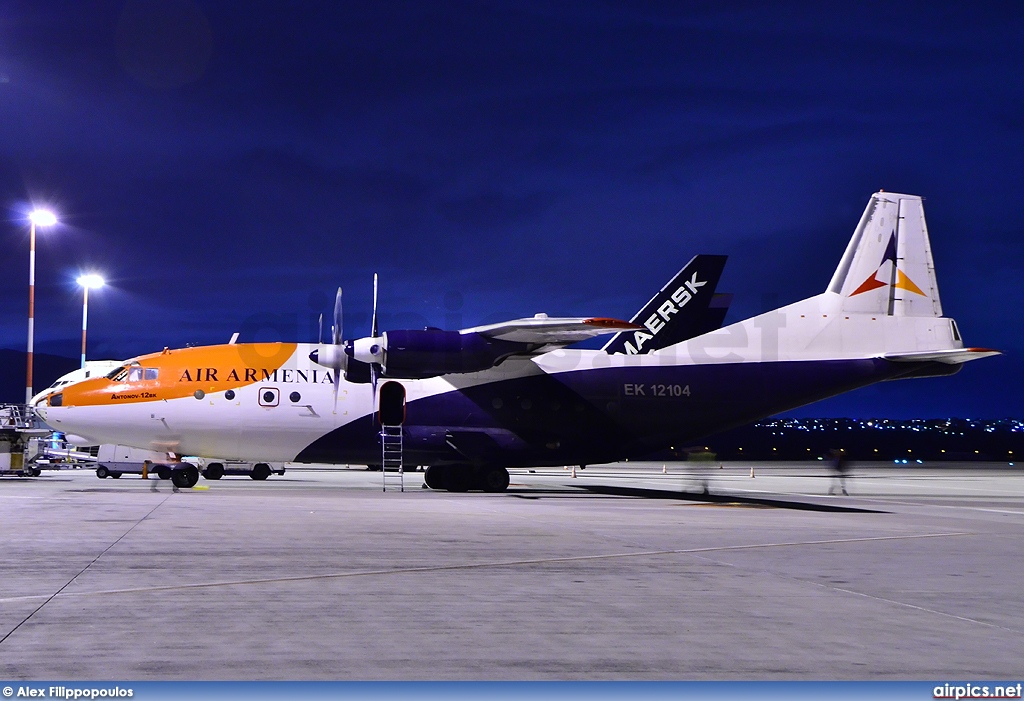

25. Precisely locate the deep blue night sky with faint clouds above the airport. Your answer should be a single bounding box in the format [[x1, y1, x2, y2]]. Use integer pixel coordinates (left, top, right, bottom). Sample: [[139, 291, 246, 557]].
[[0, 0, 1024, 418]]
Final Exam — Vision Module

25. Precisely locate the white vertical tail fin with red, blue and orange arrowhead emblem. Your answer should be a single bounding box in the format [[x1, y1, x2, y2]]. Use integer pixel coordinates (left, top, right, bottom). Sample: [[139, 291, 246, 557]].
[[828, 192, 942, 316]]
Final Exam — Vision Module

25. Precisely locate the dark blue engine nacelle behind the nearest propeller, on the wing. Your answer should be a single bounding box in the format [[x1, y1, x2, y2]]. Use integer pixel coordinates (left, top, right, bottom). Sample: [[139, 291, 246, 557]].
[[381, 328, 509, 380]]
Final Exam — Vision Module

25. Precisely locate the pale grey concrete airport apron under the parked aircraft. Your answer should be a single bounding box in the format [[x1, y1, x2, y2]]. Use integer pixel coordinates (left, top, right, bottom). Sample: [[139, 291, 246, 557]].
[[0, 464, 1024, 680]]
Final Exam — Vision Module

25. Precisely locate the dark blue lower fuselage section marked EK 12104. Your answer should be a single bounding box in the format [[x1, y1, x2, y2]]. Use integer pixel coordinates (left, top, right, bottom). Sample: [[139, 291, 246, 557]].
[[296, 359, 959, 467]]
